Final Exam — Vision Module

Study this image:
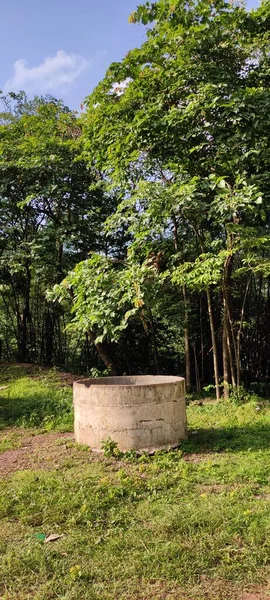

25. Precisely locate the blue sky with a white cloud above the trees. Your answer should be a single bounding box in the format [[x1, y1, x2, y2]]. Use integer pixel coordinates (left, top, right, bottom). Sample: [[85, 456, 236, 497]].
[[0, 0, 257, 110]]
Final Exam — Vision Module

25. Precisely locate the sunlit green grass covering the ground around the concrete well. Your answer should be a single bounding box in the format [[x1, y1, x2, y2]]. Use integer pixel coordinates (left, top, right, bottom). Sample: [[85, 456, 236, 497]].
[[0, 367, 270, 600]]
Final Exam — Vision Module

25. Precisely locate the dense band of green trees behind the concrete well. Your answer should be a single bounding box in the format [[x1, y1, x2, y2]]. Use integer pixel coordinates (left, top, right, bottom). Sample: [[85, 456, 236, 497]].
[[0, 0, 270, 397]]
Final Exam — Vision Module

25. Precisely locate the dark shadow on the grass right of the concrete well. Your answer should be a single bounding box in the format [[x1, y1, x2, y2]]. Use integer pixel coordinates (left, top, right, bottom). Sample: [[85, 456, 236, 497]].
[[181, 423, 270, 454]]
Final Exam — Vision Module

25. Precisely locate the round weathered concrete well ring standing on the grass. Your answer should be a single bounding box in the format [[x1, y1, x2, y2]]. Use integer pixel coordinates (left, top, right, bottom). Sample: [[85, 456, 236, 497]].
[[73, 375, 187, 452]]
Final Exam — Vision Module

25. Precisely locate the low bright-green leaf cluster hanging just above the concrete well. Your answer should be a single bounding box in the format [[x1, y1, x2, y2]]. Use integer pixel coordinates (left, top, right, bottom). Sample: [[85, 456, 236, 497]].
[[48, 254, 162, 342]]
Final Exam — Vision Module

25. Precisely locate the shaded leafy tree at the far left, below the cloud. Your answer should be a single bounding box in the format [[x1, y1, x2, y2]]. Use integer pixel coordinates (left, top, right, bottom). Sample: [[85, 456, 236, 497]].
[[0, 96, 114, 364]]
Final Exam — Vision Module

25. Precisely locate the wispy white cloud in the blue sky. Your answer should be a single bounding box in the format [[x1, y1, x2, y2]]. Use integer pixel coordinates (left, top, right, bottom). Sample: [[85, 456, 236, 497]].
[[4, 50, 89, 93]]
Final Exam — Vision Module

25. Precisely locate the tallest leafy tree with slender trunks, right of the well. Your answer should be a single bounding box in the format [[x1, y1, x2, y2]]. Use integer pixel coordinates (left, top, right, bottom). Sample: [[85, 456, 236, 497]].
[[83, 0, 269, 397]]
